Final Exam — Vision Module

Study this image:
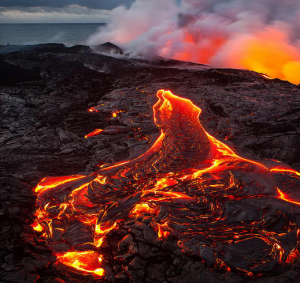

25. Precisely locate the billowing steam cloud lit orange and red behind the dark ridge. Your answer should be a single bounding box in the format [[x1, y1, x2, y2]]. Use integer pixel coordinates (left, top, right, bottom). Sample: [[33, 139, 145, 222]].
[[88, 0, 300, 83]]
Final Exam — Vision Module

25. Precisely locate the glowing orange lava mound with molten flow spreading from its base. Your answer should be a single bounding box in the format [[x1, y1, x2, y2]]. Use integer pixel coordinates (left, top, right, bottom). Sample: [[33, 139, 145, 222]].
[[32, 90, 300, 278]]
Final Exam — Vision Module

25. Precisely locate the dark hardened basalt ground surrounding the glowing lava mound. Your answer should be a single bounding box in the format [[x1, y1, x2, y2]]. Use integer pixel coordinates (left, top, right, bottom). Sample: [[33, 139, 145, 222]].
[[0, 45, 300, 282]]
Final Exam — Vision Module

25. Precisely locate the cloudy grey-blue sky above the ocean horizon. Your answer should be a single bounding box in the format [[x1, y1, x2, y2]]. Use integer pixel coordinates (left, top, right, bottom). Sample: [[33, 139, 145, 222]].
[[0, 0, 134, 23]]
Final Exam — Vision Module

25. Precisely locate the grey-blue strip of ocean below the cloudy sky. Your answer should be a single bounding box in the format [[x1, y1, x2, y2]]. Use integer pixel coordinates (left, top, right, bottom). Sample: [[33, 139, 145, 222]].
[[0, 23, 105, 46]]
